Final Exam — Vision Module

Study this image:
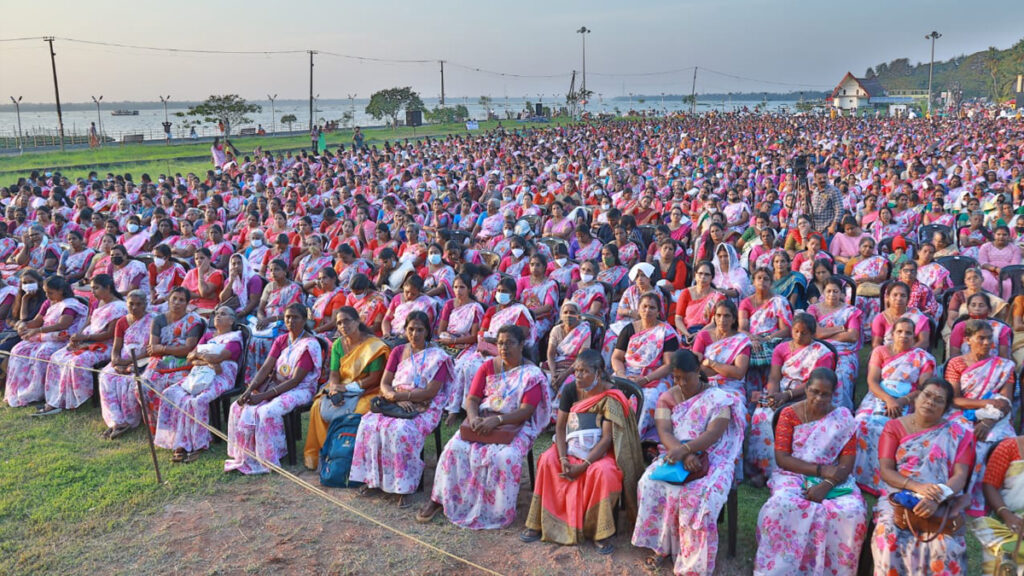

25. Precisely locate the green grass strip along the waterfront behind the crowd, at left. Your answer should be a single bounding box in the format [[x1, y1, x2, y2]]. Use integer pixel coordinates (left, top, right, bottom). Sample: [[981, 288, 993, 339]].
[[0, 119, 567, 180]]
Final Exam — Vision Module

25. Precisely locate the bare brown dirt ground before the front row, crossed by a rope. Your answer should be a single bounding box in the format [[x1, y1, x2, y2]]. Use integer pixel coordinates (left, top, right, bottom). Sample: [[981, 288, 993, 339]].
[[74, 463, 750, 576]]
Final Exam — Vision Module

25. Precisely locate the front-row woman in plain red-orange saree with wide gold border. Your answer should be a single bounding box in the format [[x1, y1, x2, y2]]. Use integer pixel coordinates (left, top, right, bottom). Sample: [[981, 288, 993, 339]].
[[519, 349, 643, 554]]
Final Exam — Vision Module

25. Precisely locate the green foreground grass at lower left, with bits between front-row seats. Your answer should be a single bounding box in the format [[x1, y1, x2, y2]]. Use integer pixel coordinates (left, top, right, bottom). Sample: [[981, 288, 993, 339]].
[[0, 342, 981, 574]]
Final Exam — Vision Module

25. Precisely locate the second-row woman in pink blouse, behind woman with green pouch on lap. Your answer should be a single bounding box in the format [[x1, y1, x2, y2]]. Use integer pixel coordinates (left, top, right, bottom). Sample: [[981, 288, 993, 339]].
[[745, 313, 836, 486]]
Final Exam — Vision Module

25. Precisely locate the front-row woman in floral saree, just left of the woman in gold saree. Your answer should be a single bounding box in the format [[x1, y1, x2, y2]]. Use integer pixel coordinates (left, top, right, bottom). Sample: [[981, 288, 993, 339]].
[[224, 303, 323, 475]]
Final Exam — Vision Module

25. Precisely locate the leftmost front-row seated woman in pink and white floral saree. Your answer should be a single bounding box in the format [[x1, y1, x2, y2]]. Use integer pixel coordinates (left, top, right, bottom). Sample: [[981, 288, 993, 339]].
[[4, 276, 89, 407]]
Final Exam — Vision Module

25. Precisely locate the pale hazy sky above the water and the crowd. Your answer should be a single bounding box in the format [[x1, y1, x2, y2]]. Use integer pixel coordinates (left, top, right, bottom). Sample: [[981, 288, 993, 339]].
[[0, 0, 1024, 102]]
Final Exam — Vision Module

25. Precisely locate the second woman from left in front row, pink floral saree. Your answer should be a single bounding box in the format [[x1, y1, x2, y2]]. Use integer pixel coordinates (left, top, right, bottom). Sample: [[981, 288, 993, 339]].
[[38, 274, 128, 415]]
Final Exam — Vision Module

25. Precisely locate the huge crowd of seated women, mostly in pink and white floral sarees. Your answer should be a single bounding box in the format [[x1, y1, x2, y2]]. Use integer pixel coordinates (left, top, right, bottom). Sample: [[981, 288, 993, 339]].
[[6, 111, 1024, 576]]
